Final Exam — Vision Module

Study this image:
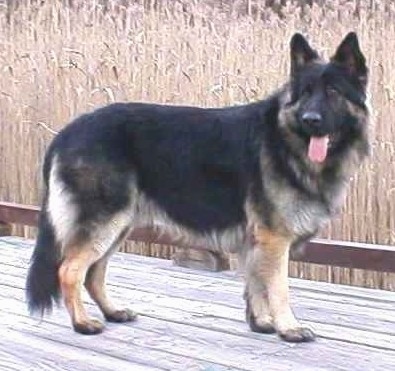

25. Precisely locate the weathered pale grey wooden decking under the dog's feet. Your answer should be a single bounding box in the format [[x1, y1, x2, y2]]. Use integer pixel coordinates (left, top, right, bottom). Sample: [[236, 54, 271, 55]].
[[0, 237, 395, 371]]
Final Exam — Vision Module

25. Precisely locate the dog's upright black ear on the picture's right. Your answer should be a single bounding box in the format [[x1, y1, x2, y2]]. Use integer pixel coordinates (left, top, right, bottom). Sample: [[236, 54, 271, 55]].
[[331, 32, 368, 85]]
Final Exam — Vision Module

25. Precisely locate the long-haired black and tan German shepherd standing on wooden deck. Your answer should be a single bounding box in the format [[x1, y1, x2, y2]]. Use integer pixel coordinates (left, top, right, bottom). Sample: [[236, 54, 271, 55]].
[[26, 32, 369, 342]]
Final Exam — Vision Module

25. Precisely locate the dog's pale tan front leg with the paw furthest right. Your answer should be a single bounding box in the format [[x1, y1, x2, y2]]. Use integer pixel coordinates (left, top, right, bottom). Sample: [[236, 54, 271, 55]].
[[246, 227, 314, 342]]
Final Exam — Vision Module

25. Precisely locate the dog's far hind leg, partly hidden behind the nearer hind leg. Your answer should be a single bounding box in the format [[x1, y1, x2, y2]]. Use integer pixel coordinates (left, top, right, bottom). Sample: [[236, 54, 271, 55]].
[[85, 229, 137, 322]]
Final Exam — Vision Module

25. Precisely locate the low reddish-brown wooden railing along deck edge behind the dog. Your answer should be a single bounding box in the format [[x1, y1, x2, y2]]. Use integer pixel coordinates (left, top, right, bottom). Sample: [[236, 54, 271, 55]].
[[0, 202, 395, 273]]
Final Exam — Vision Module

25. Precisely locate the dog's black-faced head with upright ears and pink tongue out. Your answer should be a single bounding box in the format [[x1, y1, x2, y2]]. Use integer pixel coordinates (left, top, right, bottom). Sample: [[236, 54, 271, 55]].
[[279, 32, 368, 163]]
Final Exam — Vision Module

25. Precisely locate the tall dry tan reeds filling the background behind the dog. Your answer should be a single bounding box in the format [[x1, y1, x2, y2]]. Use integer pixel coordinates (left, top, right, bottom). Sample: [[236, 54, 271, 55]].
[[0, 0, 395, 288]]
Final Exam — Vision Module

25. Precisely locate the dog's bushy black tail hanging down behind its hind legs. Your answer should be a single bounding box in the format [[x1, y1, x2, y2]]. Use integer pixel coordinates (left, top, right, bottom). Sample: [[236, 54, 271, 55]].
[[26, 202, 61, 316]]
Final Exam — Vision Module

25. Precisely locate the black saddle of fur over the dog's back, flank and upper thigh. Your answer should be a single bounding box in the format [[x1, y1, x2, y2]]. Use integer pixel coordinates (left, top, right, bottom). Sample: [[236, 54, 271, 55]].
[[51, 97, 278, 233]]
